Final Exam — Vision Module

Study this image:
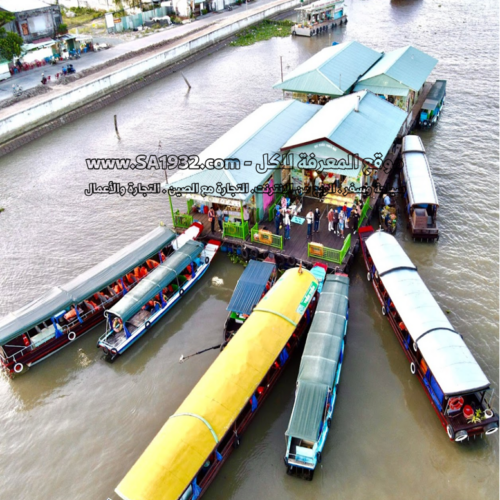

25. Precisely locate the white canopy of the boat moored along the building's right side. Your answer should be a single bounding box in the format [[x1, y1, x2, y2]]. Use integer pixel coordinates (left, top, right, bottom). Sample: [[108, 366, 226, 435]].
[[402, 135, 439, 206]]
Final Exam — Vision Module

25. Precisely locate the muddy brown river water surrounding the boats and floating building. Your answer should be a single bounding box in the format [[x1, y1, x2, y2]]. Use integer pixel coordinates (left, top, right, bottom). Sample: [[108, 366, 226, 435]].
[[0, 0, 500, 500]]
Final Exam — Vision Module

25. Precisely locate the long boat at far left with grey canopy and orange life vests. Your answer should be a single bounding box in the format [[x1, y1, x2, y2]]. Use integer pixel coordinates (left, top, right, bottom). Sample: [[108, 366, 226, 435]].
[[0, 224, 191, 375]]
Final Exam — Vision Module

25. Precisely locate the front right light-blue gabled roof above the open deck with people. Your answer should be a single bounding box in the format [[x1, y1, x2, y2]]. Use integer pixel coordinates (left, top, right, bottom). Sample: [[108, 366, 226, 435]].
[[283, 91, 407, 165]]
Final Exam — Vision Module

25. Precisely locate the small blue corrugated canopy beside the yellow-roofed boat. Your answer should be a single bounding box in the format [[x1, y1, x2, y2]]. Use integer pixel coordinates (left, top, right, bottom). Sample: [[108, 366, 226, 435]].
[[227, 260, 276, 314]]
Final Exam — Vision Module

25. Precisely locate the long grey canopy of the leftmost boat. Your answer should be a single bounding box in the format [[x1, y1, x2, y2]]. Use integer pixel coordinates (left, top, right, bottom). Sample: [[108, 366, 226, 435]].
[[0, 227, 175, 345]]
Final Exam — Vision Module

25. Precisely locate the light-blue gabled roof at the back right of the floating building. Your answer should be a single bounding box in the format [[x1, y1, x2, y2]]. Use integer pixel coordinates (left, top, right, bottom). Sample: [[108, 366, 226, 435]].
[[356, 45, 438, 91]]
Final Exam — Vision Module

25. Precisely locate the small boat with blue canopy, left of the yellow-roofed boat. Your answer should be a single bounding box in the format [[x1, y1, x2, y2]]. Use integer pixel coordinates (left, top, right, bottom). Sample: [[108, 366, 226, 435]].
[[224, 254, 277, 342]]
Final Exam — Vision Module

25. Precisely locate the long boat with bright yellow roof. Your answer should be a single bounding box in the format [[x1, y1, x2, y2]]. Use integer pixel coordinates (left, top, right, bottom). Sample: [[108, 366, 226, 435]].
[[115, 268, 325, 500]]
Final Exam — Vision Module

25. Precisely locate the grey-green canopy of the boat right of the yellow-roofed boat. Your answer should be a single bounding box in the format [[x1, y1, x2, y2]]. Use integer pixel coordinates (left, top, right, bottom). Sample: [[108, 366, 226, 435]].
[[285, 275, 349, 443]]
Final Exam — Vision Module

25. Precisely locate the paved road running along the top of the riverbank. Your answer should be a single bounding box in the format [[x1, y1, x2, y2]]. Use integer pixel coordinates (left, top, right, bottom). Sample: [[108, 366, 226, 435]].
[[0, 0, 292, 100]]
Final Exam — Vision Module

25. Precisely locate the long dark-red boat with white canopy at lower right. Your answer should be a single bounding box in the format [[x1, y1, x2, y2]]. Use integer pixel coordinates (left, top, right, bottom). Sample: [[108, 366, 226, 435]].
[[360, 226, 499, 442]]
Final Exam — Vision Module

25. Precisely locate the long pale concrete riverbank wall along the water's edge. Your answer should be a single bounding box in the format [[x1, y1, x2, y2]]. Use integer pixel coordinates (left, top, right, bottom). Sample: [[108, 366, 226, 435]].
[[0, 0, 300, 156]]
